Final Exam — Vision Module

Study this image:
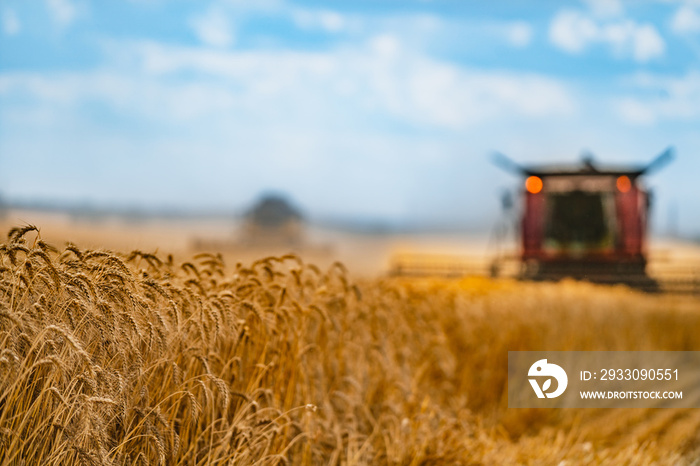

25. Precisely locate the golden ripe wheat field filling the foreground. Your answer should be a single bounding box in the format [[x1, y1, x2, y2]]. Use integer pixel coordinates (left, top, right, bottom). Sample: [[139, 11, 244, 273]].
[[0, 226, 700, 466]]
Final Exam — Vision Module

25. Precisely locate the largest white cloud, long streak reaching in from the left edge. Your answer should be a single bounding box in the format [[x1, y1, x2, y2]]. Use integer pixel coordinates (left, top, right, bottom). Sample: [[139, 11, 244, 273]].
[[0, 39, 576, 131]]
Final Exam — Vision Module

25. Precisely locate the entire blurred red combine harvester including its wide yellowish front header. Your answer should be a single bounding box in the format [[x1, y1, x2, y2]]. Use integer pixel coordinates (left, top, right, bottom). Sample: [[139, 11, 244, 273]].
[[389, 148, 700, 294]]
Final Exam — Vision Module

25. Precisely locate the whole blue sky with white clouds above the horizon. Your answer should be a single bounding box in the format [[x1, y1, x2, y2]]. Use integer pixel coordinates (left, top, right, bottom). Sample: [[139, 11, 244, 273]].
[[0, 0, 700, 235]]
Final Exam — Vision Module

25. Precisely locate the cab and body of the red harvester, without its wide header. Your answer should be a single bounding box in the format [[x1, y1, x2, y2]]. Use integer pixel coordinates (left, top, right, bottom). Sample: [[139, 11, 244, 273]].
[[495, 148, 673, 290]]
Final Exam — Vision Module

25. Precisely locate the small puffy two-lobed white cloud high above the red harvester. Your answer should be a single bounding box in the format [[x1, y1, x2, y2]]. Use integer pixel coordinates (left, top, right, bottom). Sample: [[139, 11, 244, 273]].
[[549, 10, 666, 62]]
